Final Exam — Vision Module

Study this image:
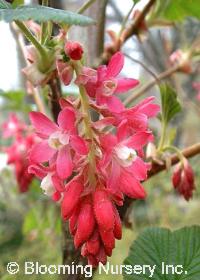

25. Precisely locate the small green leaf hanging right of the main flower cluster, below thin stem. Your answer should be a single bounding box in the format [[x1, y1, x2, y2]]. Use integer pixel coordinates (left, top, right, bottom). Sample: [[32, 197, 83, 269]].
[[160, 84, 181, 124]]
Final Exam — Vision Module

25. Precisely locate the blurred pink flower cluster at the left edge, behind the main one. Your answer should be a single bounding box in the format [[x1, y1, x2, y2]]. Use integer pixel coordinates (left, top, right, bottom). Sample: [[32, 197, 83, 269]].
[[2, 114, 36, 192]]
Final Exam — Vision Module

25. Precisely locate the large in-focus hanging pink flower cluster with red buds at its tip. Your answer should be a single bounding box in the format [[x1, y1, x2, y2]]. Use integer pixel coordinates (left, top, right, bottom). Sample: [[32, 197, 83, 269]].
[[29, 49, 159, 266]]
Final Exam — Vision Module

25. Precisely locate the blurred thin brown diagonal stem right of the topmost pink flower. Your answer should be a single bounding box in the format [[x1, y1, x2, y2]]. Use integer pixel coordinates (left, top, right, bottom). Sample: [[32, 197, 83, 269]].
[[124, 64, 180, 106]]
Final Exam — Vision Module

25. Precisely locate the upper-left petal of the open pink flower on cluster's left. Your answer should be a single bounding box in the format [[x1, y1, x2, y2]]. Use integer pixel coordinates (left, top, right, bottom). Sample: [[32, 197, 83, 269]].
[[29, 112, 58, 138]]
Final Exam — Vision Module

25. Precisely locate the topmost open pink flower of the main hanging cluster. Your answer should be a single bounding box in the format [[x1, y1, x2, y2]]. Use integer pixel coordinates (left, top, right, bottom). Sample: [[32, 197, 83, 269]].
[[76, 52, 139, 112]]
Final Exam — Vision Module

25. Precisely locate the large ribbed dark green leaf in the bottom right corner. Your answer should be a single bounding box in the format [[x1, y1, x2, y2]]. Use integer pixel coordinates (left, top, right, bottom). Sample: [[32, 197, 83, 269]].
[[124, 226, 200, 280]]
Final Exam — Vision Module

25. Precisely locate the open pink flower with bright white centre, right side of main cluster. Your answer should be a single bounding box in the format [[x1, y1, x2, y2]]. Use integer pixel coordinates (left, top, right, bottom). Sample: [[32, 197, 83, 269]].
[[99, 130, 152, 199]]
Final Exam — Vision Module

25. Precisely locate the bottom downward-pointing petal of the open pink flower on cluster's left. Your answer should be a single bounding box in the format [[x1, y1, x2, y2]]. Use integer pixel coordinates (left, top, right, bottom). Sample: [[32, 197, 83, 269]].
[[56, 147, 73, 179]]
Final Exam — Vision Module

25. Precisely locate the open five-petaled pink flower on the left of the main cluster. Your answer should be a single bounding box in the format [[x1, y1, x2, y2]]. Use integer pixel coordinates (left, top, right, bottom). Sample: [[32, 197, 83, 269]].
[[30, 108, 88, 179]]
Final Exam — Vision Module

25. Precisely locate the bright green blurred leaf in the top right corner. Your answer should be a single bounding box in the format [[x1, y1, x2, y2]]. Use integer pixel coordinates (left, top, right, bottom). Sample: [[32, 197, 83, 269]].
[[154, 0, 200, 21]]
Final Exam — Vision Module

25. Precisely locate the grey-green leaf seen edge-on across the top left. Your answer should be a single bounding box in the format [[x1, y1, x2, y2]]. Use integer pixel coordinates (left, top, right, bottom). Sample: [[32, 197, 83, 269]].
[[0, 5, 94, 26]]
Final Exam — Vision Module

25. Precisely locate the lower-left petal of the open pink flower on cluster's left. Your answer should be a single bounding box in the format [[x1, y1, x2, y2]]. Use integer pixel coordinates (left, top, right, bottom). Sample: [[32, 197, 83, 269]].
[[30, 140, 56, 163]]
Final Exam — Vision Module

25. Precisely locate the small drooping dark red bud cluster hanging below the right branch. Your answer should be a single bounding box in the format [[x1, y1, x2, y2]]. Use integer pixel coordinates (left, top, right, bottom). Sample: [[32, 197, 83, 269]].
[[172, 158, 195, 200]]
